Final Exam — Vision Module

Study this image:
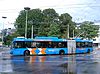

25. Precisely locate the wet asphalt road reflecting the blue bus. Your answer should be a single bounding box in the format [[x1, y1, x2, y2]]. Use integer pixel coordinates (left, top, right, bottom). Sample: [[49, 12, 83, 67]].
[[0, 48, 100, 74]]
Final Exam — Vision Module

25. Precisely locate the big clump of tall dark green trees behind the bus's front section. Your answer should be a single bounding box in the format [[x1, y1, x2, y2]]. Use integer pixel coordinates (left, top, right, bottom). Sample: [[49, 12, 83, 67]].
[[15, 9, 75, 38]]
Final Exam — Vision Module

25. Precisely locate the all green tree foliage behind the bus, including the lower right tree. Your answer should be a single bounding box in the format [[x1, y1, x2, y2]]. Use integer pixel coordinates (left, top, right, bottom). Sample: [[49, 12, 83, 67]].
[[15, 9, 97, 38]]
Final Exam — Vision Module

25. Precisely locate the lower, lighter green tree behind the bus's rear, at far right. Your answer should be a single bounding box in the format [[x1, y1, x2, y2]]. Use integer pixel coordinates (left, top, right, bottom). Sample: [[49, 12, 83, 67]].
[[76, 21, 99, 39]]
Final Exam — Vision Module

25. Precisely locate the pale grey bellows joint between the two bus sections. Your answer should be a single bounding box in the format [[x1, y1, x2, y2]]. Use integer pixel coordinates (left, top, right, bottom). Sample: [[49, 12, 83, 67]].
[[67, 40, 76, 54]]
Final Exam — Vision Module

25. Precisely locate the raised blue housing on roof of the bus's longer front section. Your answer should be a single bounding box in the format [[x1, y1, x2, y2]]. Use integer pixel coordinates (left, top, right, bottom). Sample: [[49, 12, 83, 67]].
[[34, 37, 67, 41]]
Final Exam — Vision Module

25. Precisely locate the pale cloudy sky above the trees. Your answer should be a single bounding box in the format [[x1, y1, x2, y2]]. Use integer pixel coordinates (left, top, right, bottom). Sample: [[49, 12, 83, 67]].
[[0, 0, 100, 30]]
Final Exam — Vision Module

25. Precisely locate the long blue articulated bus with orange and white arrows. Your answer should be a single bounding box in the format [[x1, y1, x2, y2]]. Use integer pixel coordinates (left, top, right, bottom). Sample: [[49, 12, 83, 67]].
[[10, 37, 93, 56]]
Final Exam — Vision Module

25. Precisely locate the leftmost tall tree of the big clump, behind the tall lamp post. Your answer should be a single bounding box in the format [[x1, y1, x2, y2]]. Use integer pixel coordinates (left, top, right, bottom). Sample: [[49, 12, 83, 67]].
[[15, 9, 43, 38]]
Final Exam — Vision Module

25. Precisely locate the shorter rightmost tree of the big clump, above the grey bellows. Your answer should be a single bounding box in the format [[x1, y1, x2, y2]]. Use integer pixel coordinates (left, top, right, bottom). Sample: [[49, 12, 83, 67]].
[[59, 13, 76, 38]]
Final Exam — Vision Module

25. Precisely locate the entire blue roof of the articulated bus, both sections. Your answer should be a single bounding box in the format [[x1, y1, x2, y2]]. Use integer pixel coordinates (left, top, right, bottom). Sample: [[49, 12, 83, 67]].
[[13, 37, 93, 42]]
